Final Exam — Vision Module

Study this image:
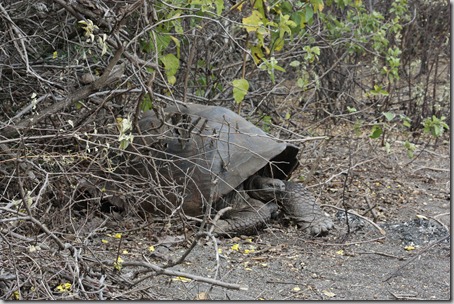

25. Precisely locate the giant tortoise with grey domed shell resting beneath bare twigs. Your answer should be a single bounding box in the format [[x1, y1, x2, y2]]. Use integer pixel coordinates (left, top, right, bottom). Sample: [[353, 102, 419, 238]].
[[128, 104, 333, 236]]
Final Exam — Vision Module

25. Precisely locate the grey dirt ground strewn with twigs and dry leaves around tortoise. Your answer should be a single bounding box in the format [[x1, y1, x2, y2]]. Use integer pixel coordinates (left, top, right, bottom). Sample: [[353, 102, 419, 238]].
[[0, 120, 451, 300]]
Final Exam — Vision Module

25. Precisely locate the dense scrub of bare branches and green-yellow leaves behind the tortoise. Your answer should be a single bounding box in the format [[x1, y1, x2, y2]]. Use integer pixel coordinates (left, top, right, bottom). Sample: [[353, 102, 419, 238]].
[[0, 0, 451, 299]]
